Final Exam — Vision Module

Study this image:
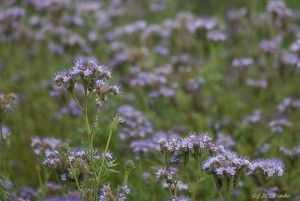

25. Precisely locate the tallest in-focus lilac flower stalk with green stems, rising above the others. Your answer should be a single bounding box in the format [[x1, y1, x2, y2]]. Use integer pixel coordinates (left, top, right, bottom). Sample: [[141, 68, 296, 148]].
[[50, 57, 121, 201]]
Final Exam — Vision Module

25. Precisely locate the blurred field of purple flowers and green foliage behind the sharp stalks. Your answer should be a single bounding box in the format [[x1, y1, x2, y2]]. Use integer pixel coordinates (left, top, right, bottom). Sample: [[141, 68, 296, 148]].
[[0, 0, 300, 201]]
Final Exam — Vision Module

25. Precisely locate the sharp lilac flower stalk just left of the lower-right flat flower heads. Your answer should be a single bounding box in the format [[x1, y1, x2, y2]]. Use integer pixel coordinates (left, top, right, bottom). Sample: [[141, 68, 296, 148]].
[[156, 134, 212, 200]]
